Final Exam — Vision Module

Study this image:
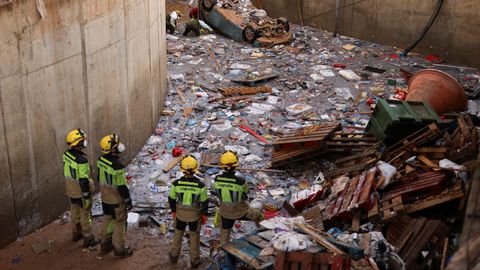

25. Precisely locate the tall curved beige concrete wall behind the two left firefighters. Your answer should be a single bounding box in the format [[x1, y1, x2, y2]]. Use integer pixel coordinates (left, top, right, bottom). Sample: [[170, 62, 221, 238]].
[[0, 0, 166, 246]]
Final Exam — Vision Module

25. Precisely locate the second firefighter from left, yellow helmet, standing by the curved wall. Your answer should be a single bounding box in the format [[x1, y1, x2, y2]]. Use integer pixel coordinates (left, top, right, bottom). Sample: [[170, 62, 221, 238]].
[[97, 134, 133, 258]]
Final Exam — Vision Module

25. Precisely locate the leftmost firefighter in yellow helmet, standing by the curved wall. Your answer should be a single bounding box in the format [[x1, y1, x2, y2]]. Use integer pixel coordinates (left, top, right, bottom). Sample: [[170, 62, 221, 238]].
[[63, 128, 98, 248]]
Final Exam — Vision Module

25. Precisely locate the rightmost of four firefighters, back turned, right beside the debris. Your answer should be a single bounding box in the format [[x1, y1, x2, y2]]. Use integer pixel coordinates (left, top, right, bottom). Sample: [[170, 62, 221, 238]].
[[212, 151, 263, 245]]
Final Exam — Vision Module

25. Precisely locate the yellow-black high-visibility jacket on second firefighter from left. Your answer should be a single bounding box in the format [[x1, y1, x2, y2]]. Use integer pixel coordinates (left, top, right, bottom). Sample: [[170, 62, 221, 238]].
[[97, 154, 131, 204]]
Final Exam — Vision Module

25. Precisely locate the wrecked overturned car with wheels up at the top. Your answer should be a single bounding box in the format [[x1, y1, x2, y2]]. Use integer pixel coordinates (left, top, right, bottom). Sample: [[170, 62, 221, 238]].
[[198, 0, 292, 47]]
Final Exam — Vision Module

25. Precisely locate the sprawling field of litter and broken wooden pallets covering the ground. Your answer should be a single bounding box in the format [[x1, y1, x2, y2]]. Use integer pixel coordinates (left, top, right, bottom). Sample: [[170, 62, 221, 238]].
[[114, 1, 480, 269]]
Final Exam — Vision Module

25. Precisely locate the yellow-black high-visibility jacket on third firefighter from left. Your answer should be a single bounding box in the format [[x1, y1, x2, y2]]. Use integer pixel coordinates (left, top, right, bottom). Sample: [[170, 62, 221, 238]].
[[168, 176, 208, 222]]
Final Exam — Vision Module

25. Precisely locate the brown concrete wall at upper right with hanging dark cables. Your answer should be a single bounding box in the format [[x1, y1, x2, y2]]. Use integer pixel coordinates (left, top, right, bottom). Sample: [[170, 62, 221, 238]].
[[252, 0, 480, 68]]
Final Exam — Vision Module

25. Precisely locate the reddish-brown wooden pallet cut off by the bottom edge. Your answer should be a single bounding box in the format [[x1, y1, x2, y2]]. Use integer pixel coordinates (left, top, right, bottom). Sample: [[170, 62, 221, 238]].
[[274, 251, 350, 270]]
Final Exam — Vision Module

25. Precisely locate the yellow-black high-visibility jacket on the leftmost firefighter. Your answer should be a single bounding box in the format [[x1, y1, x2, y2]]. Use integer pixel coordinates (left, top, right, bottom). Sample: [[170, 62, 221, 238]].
[[63, 149, 90, 199]]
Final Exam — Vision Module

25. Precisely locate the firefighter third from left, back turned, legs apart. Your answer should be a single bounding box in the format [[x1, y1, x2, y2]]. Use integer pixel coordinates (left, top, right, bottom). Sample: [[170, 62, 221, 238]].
[[168, 155, 208, 268]]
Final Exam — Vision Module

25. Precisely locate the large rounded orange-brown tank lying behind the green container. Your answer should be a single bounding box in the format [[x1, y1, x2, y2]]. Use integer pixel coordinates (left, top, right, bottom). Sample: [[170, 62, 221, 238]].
[[406, 69, 467, 114]]
